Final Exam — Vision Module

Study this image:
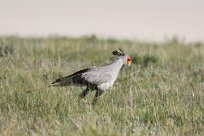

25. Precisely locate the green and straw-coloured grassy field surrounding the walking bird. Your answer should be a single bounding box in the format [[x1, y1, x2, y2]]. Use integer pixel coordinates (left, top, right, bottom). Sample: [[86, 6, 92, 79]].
[[0, 36, 204, 136]]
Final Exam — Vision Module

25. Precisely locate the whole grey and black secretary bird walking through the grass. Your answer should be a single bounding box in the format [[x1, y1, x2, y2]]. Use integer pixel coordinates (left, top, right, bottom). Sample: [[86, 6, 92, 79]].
[[52, 49, 131, 103]]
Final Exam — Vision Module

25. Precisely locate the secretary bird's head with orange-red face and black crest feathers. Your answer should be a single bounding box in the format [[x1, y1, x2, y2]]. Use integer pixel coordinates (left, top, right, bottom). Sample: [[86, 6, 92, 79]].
[[112, 48, 132, 66]]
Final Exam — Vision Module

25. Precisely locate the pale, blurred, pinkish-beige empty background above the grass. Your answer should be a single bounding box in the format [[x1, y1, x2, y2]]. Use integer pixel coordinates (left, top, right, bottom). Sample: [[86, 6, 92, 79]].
[[0, 0, 204, 41]]
